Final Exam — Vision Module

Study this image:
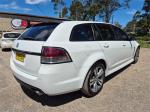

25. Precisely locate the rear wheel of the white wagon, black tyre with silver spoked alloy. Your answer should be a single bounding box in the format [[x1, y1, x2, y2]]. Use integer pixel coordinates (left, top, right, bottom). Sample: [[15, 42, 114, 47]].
[[81, 62, 105, 97]]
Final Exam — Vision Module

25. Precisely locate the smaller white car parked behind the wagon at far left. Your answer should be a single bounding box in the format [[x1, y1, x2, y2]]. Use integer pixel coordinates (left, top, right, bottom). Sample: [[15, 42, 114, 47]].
[[1, 32, 20, 50]]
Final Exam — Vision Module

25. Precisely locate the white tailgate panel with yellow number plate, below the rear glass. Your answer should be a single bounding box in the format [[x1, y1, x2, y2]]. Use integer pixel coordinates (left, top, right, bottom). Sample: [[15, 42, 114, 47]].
[[12, 40, 44, 76]]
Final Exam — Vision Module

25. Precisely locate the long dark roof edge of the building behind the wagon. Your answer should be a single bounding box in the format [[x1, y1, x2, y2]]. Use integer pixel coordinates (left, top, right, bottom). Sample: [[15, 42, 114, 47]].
[[0, 12, 71, 23]]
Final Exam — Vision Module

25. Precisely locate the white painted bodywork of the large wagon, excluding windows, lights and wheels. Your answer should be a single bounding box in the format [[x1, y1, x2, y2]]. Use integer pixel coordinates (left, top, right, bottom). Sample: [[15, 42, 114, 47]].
[[10, 21, 139, 95]]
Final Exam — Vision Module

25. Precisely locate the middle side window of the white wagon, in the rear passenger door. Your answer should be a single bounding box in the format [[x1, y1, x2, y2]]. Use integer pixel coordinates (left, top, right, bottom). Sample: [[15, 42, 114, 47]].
[[97, 24, 115, 41]]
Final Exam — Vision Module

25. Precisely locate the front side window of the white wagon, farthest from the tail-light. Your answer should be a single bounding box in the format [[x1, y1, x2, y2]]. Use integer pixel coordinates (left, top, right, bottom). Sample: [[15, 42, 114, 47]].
[[113, 26, 129, 41]]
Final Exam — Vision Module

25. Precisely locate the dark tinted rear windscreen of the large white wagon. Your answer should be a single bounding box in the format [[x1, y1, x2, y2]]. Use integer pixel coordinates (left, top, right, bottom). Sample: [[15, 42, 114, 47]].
[[19, 23, 58, 41]]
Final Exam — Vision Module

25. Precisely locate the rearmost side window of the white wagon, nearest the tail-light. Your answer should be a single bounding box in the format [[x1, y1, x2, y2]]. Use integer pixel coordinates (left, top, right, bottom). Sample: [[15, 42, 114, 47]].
[[70, 24, 94, 41]]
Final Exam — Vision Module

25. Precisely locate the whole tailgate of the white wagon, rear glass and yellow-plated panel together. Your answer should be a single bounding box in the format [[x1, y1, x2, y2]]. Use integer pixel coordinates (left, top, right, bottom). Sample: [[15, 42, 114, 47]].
[[12, 24, 58, 76]]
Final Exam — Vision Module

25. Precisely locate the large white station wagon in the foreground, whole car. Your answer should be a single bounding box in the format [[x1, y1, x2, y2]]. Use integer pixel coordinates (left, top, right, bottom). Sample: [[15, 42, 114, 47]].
[[10, 21, 140, 97]]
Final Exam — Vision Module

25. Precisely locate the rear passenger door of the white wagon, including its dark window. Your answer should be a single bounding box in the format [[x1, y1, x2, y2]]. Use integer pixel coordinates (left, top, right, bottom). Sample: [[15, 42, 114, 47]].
[[95, 23, 124, 70]]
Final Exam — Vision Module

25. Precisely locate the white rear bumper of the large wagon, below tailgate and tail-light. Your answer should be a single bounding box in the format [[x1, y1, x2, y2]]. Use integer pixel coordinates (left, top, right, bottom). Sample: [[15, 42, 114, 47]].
[[10, 58, 81, 95]]
